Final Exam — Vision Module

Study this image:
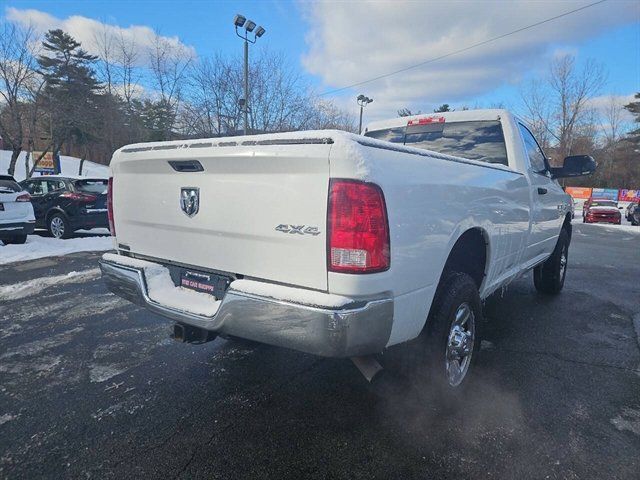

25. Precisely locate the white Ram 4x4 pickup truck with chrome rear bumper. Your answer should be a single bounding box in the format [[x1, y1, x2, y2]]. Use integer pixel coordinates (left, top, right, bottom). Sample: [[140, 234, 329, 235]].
[[101, 110, 595, 387]]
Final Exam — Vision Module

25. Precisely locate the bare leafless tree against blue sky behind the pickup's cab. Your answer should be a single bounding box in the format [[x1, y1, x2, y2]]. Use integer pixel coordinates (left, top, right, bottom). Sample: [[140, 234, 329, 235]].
[[521, 55, 606, 159]]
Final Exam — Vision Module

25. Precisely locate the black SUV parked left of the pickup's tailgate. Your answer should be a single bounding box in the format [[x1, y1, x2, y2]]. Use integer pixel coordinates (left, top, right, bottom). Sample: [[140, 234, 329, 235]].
[[20, 175, 109, 238]]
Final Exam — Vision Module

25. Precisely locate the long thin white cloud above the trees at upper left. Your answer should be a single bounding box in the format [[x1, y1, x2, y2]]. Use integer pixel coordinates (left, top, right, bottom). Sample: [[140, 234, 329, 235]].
[[5, 7, 196, 65]]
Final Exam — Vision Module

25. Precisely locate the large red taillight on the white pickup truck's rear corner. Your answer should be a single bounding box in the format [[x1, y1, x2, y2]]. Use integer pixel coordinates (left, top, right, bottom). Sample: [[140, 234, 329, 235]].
[[327, 179, 390, 273]]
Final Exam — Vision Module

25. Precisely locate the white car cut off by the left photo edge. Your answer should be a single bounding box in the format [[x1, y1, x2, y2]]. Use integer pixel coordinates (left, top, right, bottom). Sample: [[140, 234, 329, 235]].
[[0, 175, 35, 244]]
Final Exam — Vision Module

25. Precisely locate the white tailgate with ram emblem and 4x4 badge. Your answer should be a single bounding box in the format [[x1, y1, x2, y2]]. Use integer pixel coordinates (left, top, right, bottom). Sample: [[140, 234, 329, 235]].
[[112, 145, 330, 290]]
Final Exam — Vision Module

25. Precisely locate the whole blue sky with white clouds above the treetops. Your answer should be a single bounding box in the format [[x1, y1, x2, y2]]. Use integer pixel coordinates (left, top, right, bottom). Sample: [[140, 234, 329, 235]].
[[0, 0, 640, 124]]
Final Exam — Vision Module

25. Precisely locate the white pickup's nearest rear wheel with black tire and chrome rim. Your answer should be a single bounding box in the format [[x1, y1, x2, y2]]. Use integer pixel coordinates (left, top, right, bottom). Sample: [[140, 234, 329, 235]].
[[413, 273, 483, 395]]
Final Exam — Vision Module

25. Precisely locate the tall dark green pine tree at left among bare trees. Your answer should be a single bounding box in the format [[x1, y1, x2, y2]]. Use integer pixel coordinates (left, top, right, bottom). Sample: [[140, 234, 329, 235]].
[[38, 29, 101, 161]]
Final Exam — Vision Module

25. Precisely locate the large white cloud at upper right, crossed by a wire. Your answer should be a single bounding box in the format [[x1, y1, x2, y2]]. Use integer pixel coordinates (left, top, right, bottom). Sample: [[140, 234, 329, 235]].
[[301, 0, 640, 118]]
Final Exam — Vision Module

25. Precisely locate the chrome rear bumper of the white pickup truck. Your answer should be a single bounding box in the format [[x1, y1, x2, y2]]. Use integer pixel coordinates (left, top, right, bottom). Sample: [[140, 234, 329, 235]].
[[100, 259, 393, 357]]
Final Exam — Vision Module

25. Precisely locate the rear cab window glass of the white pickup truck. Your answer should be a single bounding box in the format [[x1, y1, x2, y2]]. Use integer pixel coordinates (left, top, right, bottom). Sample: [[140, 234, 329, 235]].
[[365, 121, 508, 165]]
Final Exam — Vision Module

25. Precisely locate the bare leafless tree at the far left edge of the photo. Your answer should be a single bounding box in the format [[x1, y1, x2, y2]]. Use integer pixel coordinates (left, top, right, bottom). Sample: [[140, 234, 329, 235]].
[[0, 22, 42, 175]]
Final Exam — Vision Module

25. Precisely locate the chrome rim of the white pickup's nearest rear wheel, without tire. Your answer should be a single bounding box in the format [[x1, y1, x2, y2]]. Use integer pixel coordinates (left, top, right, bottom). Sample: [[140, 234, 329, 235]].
[[445, 302, 476, 387]]
